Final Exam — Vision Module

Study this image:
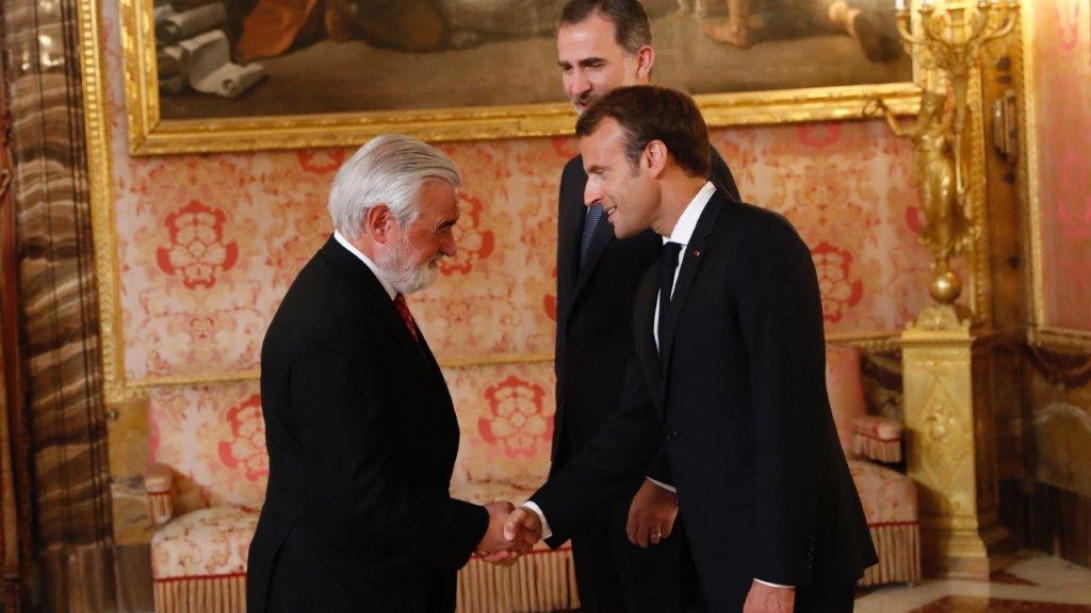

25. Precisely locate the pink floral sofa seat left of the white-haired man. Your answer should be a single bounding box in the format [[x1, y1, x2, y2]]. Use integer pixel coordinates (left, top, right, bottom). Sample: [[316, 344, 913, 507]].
[[152, 506, 257, 580]]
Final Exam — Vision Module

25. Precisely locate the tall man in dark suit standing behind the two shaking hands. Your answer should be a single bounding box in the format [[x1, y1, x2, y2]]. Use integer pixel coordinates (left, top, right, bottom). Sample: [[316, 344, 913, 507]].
[[552, 0, 739, 613]]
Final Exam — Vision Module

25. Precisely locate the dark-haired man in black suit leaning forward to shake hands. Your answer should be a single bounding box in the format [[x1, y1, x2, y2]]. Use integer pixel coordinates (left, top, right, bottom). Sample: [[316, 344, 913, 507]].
[[507, 86, 876, 613]]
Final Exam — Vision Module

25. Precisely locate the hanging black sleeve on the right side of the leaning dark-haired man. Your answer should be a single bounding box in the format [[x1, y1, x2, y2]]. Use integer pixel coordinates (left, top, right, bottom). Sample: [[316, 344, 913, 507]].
[[733, 215, 829, 586]]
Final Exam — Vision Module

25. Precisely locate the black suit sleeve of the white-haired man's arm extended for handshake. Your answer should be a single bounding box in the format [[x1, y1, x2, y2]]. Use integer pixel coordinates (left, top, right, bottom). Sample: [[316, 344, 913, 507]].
[[290, 344, 489, 570]]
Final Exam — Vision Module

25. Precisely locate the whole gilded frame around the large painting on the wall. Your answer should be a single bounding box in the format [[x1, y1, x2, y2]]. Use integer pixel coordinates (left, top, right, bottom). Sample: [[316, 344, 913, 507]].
[[115, 0, 921, 156]]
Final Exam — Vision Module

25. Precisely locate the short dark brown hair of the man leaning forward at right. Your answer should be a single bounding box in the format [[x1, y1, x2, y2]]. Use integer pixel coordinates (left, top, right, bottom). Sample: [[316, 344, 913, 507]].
[[576, 85, 712, 177]]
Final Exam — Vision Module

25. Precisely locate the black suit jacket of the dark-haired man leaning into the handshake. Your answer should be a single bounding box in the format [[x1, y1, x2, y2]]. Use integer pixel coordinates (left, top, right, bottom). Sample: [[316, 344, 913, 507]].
[[532, 191, 876, 612]]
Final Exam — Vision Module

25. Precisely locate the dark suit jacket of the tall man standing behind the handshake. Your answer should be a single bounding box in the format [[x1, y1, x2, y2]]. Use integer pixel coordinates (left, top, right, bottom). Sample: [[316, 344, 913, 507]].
[[552, 148, 739, 477]]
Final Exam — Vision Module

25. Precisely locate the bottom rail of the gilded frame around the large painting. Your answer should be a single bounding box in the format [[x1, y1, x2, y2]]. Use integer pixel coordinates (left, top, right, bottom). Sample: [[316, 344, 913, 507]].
[[129, 84, 920, 156]]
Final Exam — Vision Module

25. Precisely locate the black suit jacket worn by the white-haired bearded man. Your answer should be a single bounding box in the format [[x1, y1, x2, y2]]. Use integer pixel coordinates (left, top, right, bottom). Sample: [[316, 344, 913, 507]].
[[247, 238, 488, 613]]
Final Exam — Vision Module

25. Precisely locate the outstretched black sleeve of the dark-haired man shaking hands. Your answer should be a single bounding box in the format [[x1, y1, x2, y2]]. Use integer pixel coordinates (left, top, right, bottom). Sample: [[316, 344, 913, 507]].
[[530, 357, 663, 548]]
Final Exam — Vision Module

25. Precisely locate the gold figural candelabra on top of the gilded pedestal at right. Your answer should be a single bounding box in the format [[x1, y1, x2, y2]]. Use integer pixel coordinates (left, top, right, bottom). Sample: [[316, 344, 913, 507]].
[[865, 0, 1019, 304]]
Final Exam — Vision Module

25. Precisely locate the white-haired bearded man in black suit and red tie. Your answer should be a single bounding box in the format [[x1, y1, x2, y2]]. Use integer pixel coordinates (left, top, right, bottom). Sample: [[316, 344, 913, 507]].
[[247, 136, 519, 613]]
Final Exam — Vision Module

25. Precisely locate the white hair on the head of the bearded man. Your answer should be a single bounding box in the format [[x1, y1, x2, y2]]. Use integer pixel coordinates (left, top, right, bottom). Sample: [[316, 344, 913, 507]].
[[326, 134, 461, 240]]
